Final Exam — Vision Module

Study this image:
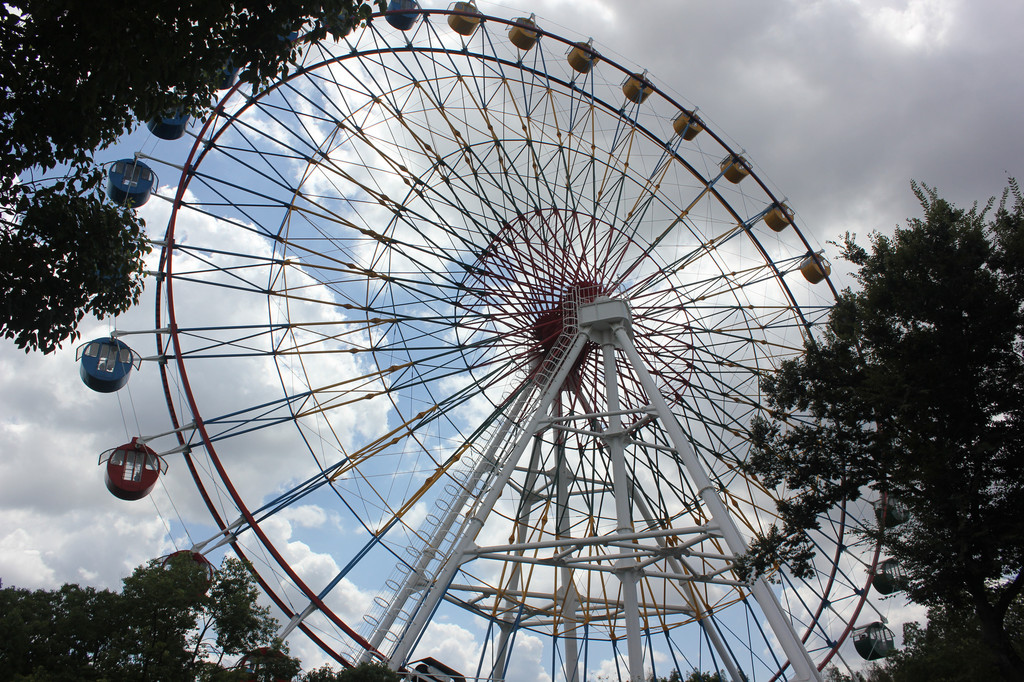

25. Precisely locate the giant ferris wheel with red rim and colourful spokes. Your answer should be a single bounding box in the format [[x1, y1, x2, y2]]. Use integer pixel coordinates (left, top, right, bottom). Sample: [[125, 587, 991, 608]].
[[97, 2, 897, 682]]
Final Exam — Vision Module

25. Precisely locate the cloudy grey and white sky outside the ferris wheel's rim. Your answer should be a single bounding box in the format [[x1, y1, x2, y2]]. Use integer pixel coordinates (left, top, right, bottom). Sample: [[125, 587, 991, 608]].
[[0, 0, 1024, 675]]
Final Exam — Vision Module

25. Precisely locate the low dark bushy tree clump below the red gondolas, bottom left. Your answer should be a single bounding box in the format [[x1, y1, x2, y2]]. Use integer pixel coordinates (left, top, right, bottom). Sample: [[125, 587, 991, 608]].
[[0, 555, 299, 682]]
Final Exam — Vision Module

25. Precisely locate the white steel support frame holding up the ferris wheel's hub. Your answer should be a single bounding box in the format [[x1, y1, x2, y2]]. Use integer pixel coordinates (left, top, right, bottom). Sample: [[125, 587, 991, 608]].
[[367, 298, 821, 682]]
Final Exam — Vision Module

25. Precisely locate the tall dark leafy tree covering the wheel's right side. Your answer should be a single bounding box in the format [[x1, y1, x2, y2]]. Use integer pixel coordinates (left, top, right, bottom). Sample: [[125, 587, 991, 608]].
[[741, 180, 1024, 679]]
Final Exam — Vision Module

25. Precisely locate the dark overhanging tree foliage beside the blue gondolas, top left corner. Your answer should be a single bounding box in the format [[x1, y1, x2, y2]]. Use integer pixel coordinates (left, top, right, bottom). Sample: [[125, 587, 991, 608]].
[[0, 0, 383, 352]]
